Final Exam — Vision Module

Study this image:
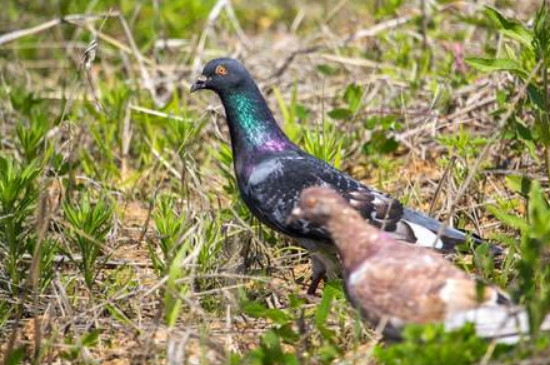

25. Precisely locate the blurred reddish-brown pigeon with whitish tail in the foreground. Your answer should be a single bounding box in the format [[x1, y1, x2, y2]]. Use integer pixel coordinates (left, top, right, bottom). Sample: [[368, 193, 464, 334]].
[[289, 187, 550, 343]]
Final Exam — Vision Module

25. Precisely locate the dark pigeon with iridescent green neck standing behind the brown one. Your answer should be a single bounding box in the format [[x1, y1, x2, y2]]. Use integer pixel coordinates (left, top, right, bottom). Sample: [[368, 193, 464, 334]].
[[191, 58, 494, 294]]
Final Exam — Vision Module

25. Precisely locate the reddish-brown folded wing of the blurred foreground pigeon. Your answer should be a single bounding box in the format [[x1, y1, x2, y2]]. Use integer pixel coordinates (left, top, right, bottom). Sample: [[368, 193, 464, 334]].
[[346, 242, 494, 323]]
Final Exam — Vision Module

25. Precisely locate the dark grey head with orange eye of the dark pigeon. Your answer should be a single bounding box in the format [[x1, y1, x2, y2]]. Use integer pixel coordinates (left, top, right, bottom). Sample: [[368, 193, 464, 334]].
[[191, 58, 250, 93]]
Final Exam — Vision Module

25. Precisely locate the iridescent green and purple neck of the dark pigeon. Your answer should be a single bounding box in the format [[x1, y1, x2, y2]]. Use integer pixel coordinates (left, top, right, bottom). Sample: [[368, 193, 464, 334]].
[[220, 85, 294, 153]]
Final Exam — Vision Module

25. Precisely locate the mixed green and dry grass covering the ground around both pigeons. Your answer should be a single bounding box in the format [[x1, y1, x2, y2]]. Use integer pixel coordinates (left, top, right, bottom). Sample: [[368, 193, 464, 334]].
[[0, 0, 550, 364]]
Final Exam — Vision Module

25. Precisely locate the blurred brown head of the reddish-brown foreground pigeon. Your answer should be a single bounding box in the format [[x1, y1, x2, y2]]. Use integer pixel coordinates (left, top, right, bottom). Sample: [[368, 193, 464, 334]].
[[289, 187, 347, 225]]
